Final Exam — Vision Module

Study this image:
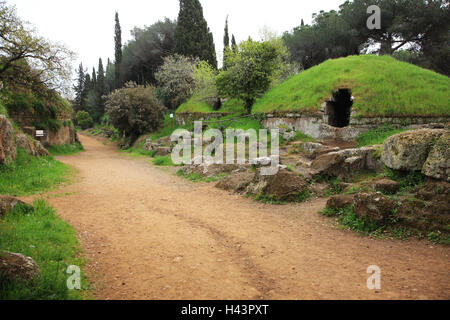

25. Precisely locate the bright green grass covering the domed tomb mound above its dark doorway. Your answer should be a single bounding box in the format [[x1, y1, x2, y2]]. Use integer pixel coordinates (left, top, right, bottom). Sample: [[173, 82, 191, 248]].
[[253, 55, 450, 116]]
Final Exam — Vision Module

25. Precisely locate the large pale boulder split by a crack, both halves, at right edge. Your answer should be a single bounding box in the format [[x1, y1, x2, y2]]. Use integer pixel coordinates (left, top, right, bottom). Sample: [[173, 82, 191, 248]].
[[381, 129, 450, 181]]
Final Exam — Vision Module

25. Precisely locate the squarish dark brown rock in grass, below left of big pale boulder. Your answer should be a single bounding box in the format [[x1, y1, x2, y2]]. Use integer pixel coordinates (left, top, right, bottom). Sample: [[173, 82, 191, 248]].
[[354, 193, 396, 223]]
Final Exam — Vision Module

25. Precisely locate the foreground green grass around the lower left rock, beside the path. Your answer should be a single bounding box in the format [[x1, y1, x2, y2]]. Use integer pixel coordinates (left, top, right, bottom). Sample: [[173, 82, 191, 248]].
[[0, 200, 88, 300]]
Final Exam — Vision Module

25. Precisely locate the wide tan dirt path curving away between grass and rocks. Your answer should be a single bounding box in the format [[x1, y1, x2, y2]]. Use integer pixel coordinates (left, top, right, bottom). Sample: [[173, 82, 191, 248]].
[[32, 136, 450, 299]]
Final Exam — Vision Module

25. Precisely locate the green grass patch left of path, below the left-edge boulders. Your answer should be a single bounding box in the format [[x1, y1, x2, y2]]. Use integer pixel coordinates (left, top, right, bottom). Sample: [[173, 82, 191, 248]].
[[0, 149, 71, 196]]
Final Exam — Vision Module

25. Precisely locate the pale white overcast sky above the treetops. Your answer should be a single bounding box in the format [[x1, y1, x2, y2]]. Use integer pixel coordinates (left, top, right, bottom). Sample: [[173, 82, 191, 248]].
[[7, 0, 344, 70]]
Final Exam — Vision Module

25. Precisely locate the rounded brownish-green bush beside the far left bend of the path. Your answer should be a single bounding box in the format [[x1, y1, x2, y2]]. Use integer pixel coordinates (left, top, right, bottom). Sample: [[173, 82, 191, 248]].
[[106, 82, 165, 141]]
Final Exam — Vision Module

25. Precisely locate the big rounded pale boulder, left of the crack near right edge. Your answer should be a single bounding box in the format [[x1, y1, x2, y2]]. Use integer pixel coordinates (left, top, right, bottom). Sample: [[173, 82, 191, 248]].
[[381, 129, 446, 171]]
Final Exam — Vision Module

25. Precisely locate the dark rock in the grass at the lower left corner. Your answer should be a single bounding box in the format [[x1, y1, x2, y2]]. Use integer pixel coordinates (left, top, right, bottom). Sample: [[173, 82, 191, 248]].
[[0, 251, 41, 282]]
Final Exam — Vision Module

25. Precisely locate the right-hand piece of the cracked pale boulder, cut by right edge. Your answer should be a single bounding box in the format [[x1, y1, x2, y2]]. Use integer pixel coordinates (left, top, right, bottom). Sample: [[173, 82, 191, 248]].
[[422, 132, 450, 182]]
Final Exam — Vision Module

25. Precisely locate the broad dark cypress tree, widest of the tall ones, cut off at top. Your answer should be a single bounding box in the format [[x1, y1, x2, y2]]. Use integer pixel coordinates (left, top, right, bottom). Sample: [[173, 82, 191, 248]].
[[175, 0, 217, 68]]
